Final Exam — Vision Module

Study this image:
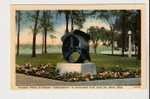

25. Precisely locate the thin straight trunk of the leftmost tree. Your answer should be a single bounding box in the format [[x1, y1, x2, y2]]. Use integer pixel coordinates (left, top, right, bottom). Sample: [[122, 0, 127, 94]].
[[17, 11, 20, 56]]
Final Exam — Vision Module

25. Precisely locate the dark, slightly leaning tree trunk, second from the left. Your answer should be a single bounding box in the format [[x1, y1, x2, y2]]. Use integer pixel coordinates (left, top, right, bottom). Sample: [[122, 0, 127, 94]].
[[32, 11, 39, 57]]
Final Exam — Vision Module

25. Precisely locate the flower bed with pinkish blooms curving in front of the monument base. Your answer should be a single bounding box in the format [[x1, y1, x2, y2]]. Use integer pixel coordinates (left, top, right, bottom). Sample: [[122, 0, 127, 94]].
[[16, 64, 141, 82]]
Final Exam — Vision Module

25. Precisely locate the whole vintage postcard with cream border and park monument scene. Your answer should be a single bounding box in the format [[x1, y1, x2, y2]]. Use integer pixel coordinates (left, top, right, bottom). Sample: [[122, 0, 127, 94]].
[[11, 4, 147, 89]]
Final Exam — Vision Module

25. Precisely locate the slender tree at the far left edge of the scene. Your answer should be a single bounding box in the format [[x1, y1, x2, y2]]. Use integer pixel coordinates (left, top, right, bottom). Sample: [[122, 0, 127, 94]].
[[16, 11, 21, 56]]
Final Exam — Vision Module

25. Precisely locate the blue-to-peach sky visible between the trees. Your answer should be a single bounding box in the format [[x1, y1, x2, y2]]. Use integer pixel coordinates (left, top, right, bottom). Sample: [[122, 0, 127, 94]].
[[16, 11, 109, 45]]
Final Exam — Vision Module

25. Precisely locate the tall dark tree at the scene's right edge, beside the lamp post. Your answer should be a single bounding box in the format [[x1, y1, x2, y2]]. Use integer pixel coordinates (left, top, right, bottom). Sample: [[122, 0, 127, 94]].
[[128, 10, 141, 59]]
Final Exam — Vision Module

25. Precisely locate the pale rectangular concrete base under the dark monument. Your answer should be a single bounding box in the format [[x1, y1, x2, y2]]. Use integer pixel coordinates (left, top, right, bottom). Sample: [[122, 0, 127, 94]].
[[57, 63, 96, 75]]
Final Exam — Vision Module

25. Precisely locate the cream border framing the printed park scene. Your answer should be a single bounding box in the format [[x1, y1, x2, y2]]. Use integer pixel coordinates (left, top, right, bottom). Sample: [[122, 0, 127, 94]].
[[10, 4, 148, 90]]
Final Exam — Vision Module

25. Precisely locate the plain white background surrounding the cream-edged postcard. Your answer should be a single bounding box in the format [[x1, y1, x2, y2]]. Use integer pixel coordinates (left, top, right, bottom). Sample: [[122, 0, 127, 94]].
[[0, 0, 149, 99]]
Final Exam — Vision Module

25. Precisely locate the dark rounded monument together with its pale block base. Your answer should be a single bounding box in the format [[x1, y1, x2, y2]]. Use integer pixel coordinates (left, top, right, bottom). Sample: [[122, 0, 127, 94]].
[[57, 30, 96, 75]]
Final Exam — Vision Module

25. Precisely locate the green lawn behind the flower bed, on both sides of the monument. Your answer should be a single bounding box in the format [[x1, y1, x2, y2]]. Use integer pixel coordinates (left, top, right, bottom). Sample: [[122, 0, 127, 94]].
[[16, 53, 140, 69]]
